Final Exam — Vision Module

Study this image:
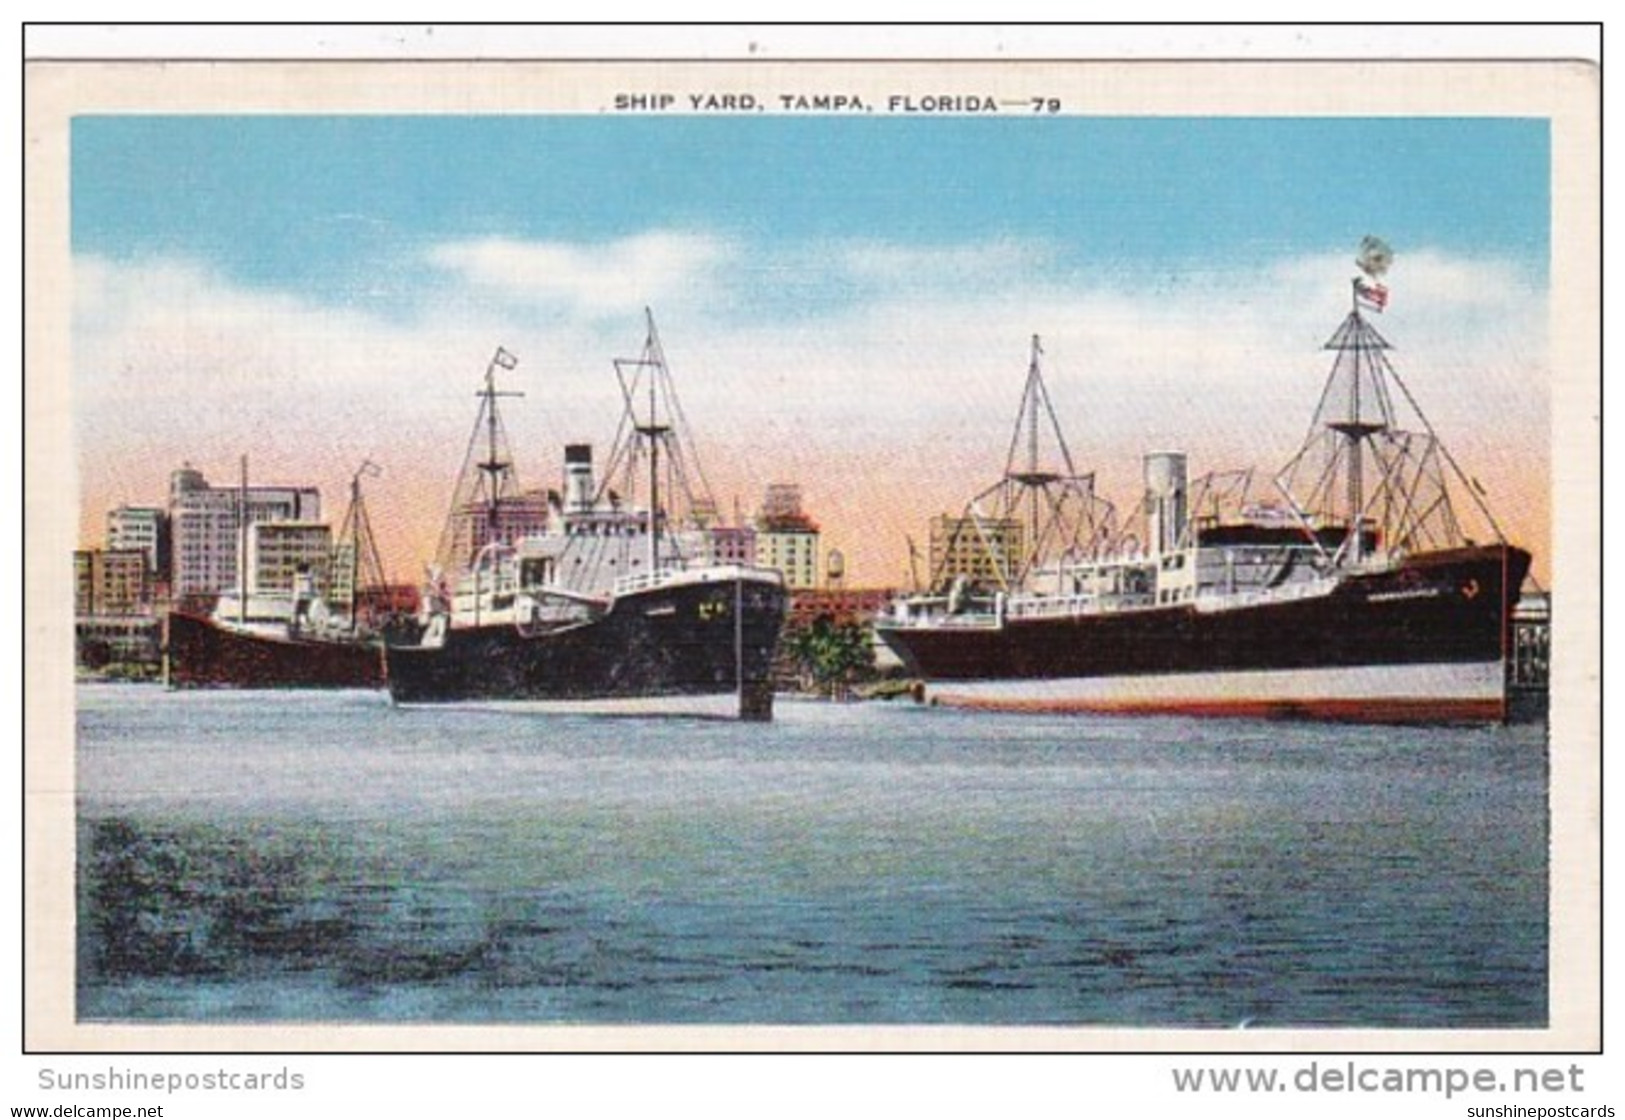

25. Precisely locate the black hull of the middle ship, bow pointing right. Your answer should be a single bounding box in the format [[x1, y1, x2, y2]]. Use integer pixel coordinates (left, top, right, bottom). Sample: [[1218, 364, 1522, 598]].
[[387, 577, 787, 718]]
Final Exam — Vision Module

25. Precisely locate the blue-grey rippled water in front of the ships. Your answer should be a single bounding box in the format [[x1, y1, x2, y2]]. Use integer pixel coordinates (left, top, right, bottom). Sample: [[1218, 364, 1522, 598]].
[[78, 686, 1547, 1027]]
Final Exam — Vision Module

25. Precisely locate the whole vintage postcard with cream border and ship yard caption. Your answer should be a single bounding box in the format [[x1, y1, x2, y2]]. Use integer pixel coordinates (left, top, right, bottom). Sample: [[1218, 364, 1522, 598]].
[[21, 32, 1601, 1089]]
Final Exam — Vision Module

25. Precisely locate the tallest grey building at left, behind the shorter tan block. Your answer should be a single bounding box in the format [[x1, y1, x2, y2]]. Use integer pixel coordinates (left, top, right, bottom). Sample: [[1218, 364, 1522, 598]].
[[169, 463, 322, 600]]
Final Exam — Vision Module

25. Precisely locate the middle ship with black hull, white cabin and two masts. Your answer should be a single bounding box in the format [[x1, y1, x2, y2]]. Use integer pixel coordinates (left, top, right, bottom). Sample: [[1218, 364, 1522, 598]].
[[387, 317, 787, 720]]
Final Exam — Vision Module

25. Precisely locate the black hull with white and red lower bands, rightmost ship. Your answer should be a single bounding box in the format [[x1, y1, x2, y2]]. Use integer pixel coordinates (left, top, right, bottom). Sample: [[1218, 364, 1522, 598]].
[[881, 545, 1529, 722]]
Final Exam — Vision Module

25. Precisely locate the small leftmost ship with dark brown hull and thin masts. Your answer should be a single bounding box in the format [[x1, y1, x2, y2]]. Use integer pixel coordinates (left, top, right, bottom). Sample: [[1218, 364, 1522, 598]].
[[164, 460, 400, 689]]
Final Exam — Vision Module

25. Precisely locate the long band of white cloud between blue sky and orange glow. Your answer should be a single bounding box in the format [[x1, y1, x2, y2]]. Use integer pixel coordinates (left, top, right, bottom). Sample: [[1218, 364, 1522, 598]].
[[75, 234, 1545, 458]]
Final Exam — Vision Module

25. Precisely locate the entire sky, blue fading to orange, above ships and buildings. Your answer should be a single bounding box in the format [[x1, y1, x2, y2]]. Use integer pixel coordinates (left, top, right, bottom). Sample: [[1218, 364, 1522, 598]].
[[72, 115, 1550, 585]]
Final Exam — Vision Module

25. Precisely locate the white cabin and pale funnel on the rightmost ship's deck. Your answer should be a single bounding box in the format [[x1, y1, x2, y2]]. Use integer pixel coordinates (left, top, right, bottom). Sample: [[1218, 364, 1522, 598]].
[[887, 452, 1352, 627]]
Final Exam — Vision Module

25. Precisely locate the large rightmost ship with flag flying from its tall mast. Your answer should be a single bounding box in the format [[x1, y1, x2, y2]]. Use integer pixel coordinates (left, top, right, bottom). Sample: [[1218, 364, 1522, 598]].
[[878, 242, 1531, 722]]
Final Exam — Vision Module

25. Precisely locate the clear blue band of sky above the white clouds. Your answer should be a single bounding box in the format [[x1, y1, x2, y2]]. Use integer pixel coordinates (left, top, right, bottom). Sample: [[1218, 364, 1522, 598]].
[[73, 115, 1550, 296]]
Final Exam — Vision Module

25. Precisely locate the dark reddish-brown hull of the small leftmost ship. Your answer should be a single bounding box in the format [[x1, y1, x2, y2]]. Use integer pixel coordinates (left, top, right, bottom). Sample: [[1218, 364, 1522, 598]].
[[164, 611, 384, 689]]
